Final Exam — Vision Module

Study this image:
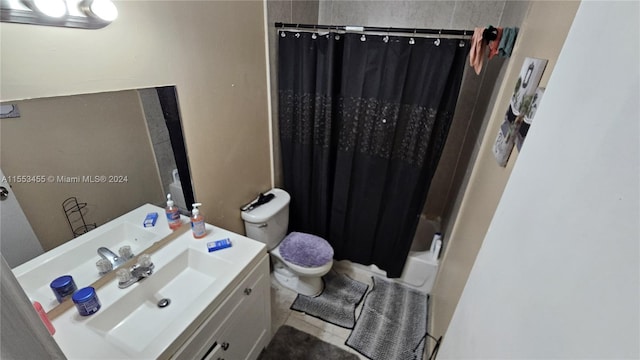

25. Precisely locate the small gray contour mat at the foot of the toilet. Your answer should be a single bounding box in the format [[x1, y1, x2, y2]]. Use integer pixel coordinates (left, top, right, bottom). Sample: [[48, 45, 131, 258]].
[[291, 271, 369, 329]]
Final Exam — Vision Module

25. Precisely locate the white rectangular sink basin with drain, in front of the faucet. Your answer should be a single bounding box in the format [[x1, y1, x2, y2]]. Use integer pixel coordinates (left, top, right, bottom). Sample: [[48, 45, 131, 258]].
[[87, 248, 233, 354]]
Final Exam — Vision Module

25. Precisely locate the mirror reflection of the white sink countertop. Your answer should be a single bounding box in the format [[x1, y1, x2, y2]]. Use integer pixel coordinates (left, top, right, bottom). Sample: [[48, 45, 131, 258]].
[[13, 205, 170, 311]]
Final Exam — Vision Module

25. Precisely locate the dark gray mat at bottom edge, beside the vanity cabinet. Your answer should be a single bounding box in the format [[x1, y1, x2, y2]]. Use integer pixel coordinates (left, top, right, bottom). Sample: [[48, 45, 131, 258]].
[[258, 325, 359, 360]]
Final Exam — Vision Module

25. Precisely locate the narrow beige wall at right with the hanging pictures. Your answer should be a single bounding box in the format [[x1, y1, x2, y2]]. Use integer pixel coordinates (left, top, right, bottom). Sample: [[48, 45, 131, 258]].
[[431, 1, 579, 336]]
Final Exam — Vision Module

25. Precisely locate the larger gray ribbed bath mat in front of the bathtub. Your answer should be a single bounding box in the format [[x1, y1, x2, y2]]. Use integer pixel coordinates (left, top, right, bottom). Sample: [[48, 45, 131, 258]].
[[346, 277, 429, 360]]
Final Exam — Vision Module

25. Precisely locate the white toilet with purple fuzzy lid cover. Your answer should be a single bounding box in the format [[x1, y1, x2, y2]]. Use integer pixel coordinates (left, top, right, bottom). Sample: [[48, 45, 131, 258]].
[[241, 189, 333, 296]]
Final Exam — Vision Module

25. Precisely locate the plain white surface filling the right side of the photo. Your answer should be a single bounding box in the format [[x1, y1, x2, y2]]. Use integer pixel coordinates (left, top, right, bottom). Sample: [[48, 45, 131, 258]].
[[438, 1, 640, 359]]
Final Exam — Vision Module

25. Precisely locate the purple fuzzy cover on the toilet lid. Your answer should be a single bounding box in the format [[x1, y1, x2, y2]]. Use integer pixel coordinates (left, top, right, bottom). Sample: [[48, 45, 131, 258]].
[[280, 232, 333, 267]]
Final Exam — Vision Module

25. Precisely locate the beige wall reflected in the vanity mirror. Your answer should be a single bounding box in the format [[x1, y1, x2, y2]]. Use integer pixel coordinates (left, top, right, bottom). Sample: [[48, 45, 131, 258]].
[[0, 90, 163, 251]]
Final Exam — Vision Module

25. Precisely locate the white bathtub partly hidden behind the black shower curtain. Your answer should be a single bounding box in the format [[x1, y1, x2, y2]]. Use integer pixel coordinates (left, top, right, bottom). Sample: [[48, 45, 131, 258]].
[[334, 215, 440, 294]]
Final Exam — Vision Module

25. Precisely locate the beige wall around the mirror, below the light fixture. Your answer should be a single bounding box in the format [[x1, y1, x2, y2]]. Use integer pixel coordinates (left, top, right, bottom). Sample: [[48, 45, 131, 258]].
[[0, 1, 271, 233]]
